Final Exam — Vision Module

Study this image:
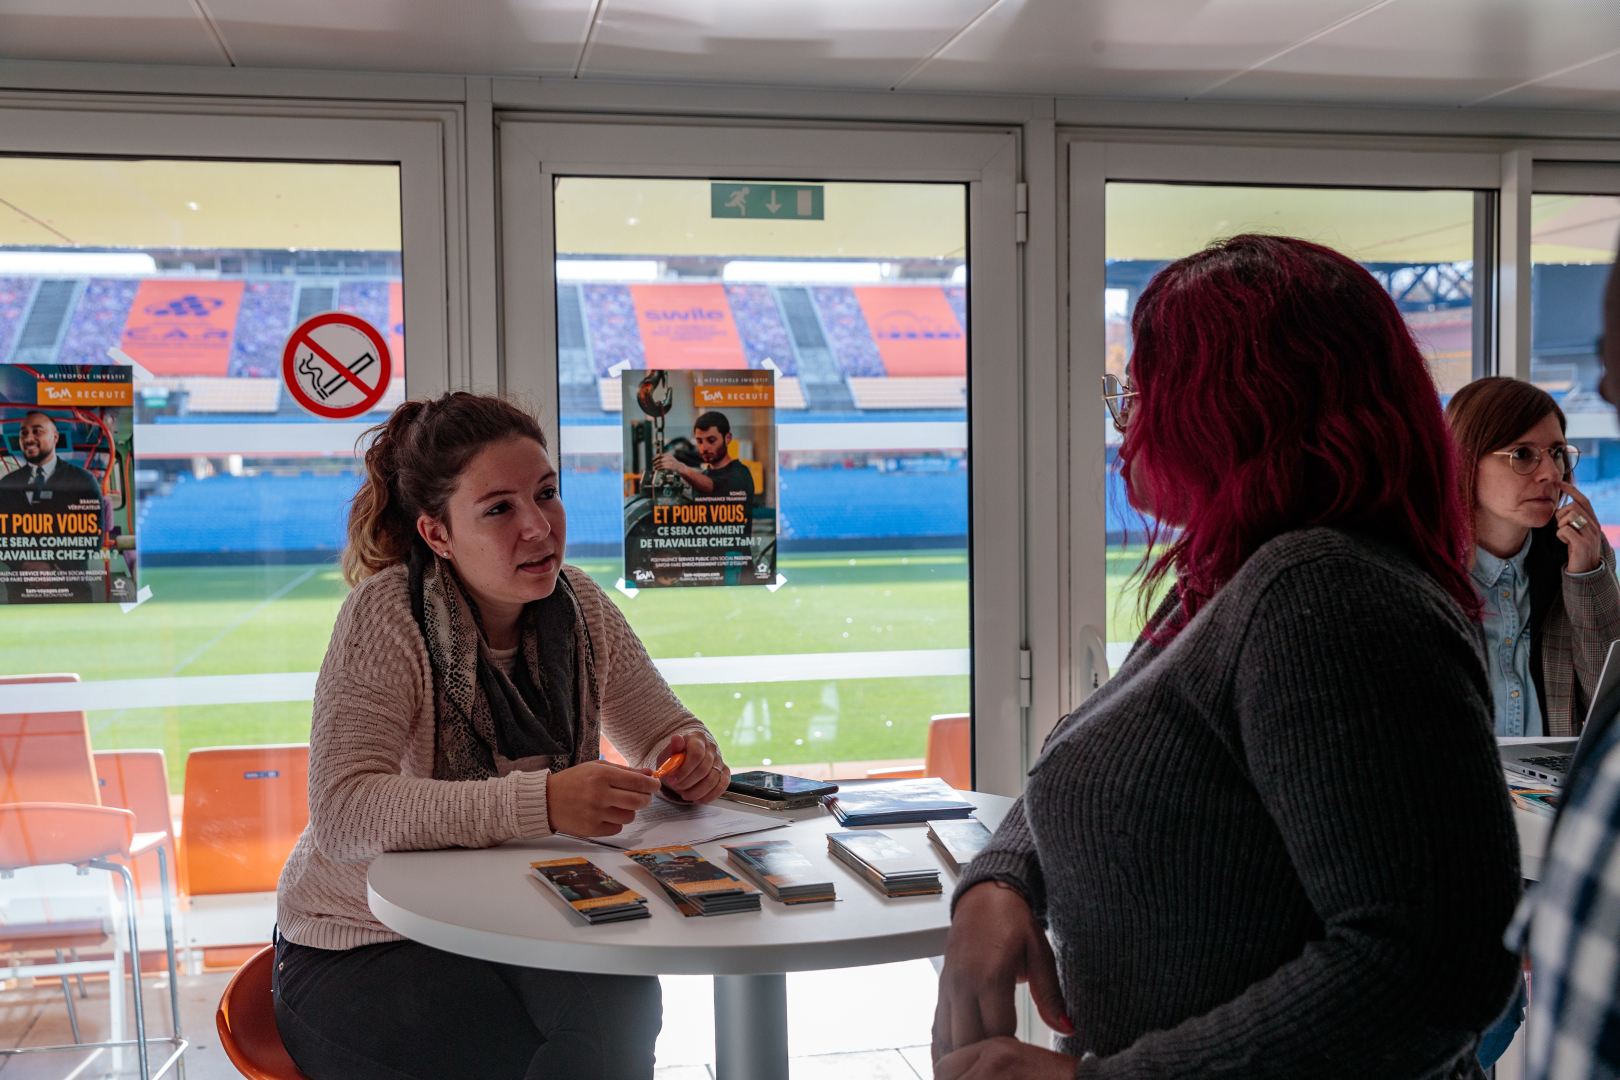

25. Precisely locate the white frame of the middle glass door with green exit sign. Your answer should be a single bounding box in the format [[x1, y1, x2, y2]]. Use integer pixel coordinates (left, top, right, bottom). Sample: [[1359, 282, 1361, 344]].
[[499, 113, 1024, 793]]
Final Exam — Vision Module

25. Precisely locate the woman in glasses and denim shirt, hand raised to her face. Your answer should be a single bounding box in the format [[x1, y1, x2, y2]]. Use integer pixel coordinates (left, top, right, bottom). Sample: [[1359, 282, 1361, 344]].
[[1445, 377, 1620, 1069]]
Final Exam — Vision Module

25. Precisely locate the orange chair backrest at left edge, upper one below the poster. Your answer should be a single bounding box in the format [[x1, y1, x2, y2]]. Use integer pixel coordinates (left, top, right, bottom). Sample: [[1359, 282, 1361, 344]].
[[0, 674, 100, 806]]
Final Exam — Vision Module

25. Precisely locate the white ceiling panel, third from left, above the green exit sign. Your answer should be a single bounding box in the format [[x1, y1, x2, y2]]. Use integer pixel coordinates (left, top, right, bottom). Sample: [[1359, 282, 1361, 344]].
[[582, 0, 993, 89]]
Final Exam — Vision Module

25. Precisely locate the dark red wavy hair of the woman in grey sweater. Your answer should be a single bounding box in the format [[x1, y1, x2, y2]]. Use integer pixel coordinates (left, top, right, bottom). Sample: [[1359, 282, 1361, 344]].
[[1119, 235, 1479, 640]]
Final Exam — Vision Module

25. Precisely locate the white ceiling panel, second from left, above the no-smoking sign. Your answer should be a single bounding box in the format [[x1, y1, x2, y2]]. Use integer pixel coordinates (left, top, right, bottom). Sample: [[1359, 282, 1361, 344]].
[[196, 0, 591, 74]]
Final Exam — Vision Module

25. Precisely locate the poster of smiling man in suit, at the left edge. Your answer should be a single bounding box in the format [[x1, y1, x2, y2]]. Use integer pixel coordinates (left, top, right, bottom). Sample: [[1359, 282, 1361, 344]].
[[0, 364, 136, 604]]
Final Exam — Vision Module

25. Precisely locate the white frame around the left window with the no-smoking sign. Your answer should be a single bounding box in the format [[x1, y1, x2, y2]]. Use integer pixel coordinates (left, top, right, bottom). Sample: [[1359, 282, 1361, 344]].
[[0, 96, 473, 408]]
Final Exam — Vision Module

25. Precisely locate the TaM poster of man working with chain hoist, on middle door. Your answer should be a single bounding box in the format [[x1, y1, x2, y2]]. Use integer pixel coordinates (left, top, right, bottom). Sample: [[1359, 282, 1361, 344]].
[[620, 369, 776, 589]]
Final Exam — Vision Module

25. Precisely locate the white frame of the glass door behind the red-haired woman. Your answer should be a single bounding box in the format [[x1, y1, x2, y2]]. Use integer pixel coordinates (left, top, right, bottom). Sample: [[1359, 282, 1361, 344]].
[[1062, 131, 1503, 757]]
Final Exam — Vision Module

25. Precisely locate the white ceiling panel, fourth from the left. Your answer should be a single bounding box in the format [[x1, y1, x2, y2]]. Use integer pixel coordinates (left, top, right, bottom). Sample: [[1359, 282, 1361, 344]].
[[907, 0, 1367, 99]]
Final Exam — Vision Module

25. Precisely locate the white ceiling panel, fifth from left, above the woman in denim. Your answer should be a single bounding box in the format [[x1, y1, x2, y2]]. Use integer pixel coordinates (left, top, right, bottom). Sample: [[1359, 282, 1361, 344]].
[[1209, 0, 1620, 105]]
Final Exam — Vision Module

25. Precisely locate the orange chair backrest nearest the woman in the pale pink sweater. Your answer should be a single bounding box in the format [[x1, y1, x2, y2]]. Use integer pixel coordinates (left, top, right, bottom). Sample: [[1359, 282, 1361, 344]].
[[180, 743, 309, 897]]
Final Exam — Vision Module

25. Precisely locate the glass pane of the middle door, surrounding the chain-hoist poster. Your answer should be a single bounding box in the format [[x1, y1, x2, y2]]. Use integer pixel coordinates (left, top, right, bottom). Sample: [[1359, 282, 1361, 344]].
[[554, 176, 970, 777]]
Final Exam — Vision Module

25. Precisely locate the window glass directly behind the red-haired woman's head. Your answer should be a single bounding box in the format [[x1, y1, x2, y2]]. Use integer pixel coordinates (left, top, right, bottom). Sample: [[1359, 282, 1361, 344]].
[[1098, 183, 1483, 669]]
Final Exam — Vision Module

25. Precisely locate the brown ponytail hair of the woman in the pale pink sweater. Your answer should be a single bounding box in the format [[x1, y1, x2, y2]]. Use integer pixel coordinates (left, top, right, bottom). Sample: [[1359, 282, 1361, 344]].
[[343, 390, 546, 586]]
